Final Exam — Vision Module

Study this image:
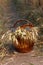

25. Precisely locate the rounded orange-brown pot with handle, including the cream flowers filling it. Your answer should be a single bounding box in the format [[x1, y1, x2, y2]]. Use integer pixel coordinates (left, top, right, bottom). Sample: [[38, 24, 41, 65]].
[[12, 20, 34, 53]]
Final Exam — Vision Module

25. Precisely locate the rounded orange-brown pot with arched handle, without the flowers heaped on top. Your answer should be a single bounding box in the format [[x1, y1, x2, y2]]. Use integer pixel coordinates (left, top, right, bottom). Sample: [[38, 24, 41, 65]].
[[12, 20, 34, 53]]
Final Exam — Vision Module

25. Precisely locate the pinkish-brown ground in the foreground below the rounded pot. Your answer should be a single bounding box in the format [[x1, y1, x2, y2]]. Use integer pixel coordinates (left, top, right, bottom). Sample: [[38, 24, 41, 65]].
[[0, 51, 43, 65]]
